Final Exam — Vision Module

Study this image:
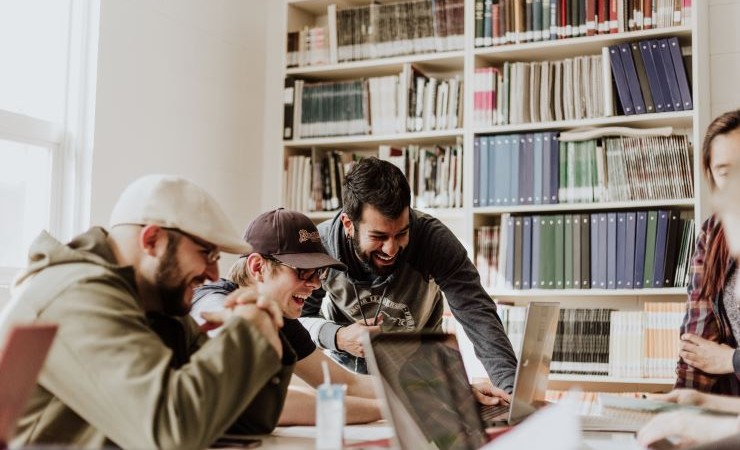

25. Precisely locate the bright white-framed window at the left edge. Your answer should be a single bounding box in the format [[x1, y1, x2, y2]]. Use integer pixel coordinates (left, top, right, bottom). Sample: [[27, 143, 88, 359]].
[[0, 0, 99, 285]]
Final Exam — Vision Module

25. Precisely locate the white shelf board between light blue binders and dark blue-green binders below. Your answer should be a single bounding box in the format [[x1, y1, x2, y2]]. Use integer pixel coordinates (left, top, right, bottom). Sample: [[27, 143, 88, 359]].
[[473, 198, 695, 215]]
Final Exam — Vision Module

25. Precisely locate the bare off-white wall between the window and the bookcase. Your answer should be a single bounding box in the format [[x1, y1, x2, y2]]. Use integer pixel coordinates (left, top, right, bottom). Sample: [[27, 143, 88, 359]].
[[91, 0, 272, 269]]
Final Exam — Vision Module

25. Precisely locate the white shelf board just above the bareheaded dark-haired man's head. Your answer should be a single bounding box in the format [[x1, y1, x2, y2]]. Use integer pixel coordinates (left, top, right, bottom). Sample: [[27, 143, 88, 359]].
[[283, 129, 463, 150]]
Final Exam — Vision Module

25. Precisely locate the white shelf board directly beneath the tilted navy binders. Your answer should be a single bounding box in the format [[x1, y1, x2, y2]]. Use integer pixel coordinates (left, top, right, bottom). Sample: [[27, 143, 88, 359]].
[[473, 111, 694, 134]]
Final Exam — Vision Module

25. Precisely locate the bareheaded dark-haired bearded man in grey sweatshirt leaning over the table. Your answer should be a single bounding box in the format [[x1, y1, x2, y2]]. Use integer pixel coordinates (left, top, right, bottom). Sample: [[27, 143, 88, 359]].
[[301, 158, 516, 402]]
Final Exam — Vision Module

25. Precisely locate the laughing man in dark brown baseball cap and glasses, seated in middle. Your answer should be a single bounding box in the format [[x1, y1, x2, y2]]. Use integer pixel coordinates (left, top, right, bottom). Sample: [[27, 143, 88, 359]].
[[191, 208, 380, 425]]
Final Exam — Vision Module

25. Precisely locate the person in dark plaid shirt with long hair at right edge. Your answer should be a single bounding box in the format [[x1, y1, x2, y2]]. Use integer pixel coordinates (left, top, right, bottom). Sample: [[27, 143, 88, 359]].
[[675, 110, 740, 395]]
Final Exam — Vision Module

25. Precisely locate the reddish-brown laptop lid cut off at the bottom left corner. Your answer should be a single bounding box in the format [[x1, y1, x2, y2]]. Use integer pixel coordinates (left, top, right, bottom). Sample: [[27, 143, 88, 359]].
[[0, 323, 57, 448]]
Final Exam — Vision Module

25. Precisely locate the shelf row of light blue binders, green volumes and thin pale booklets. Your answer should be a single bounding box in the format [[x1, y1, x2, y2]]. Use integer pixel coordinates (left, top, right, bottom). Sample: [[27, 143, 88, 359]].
[[473, 132, 694, 207]]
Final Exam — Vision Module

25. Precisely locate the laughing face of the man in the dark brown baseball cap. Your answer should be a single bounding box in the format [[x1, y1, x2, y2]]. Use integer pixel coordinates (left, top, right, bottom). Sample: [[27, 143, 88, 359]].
[[247, 253, 321, 319]]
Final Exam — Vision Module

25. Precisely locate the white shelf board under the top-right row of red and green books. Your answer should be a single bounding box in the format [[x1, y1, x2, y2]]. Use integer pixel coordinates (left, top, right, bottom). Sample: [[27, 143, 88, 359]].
[[473, 26, 691, 62]]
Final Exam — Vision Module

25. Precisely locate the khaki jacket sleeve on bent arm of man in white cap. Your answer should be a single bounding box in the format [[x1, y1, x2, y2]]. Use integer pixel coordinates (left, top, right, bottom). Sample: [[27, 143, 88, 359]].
[[39, 279, 285, 448]]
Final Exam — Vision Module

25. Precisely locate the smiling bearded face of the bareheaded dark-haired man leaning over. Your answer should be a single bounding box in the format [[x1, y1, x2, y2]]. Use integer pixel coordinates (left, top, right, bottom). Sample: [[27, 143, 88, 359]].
[[341, 205, 409, 276]]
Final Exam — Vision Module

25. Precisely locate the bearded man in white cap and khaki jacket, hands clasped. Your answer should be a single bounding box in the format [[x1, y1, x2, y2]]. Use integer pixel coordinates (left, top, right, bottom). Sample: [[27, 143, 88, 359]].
[[0, 175, 295, 449]]
